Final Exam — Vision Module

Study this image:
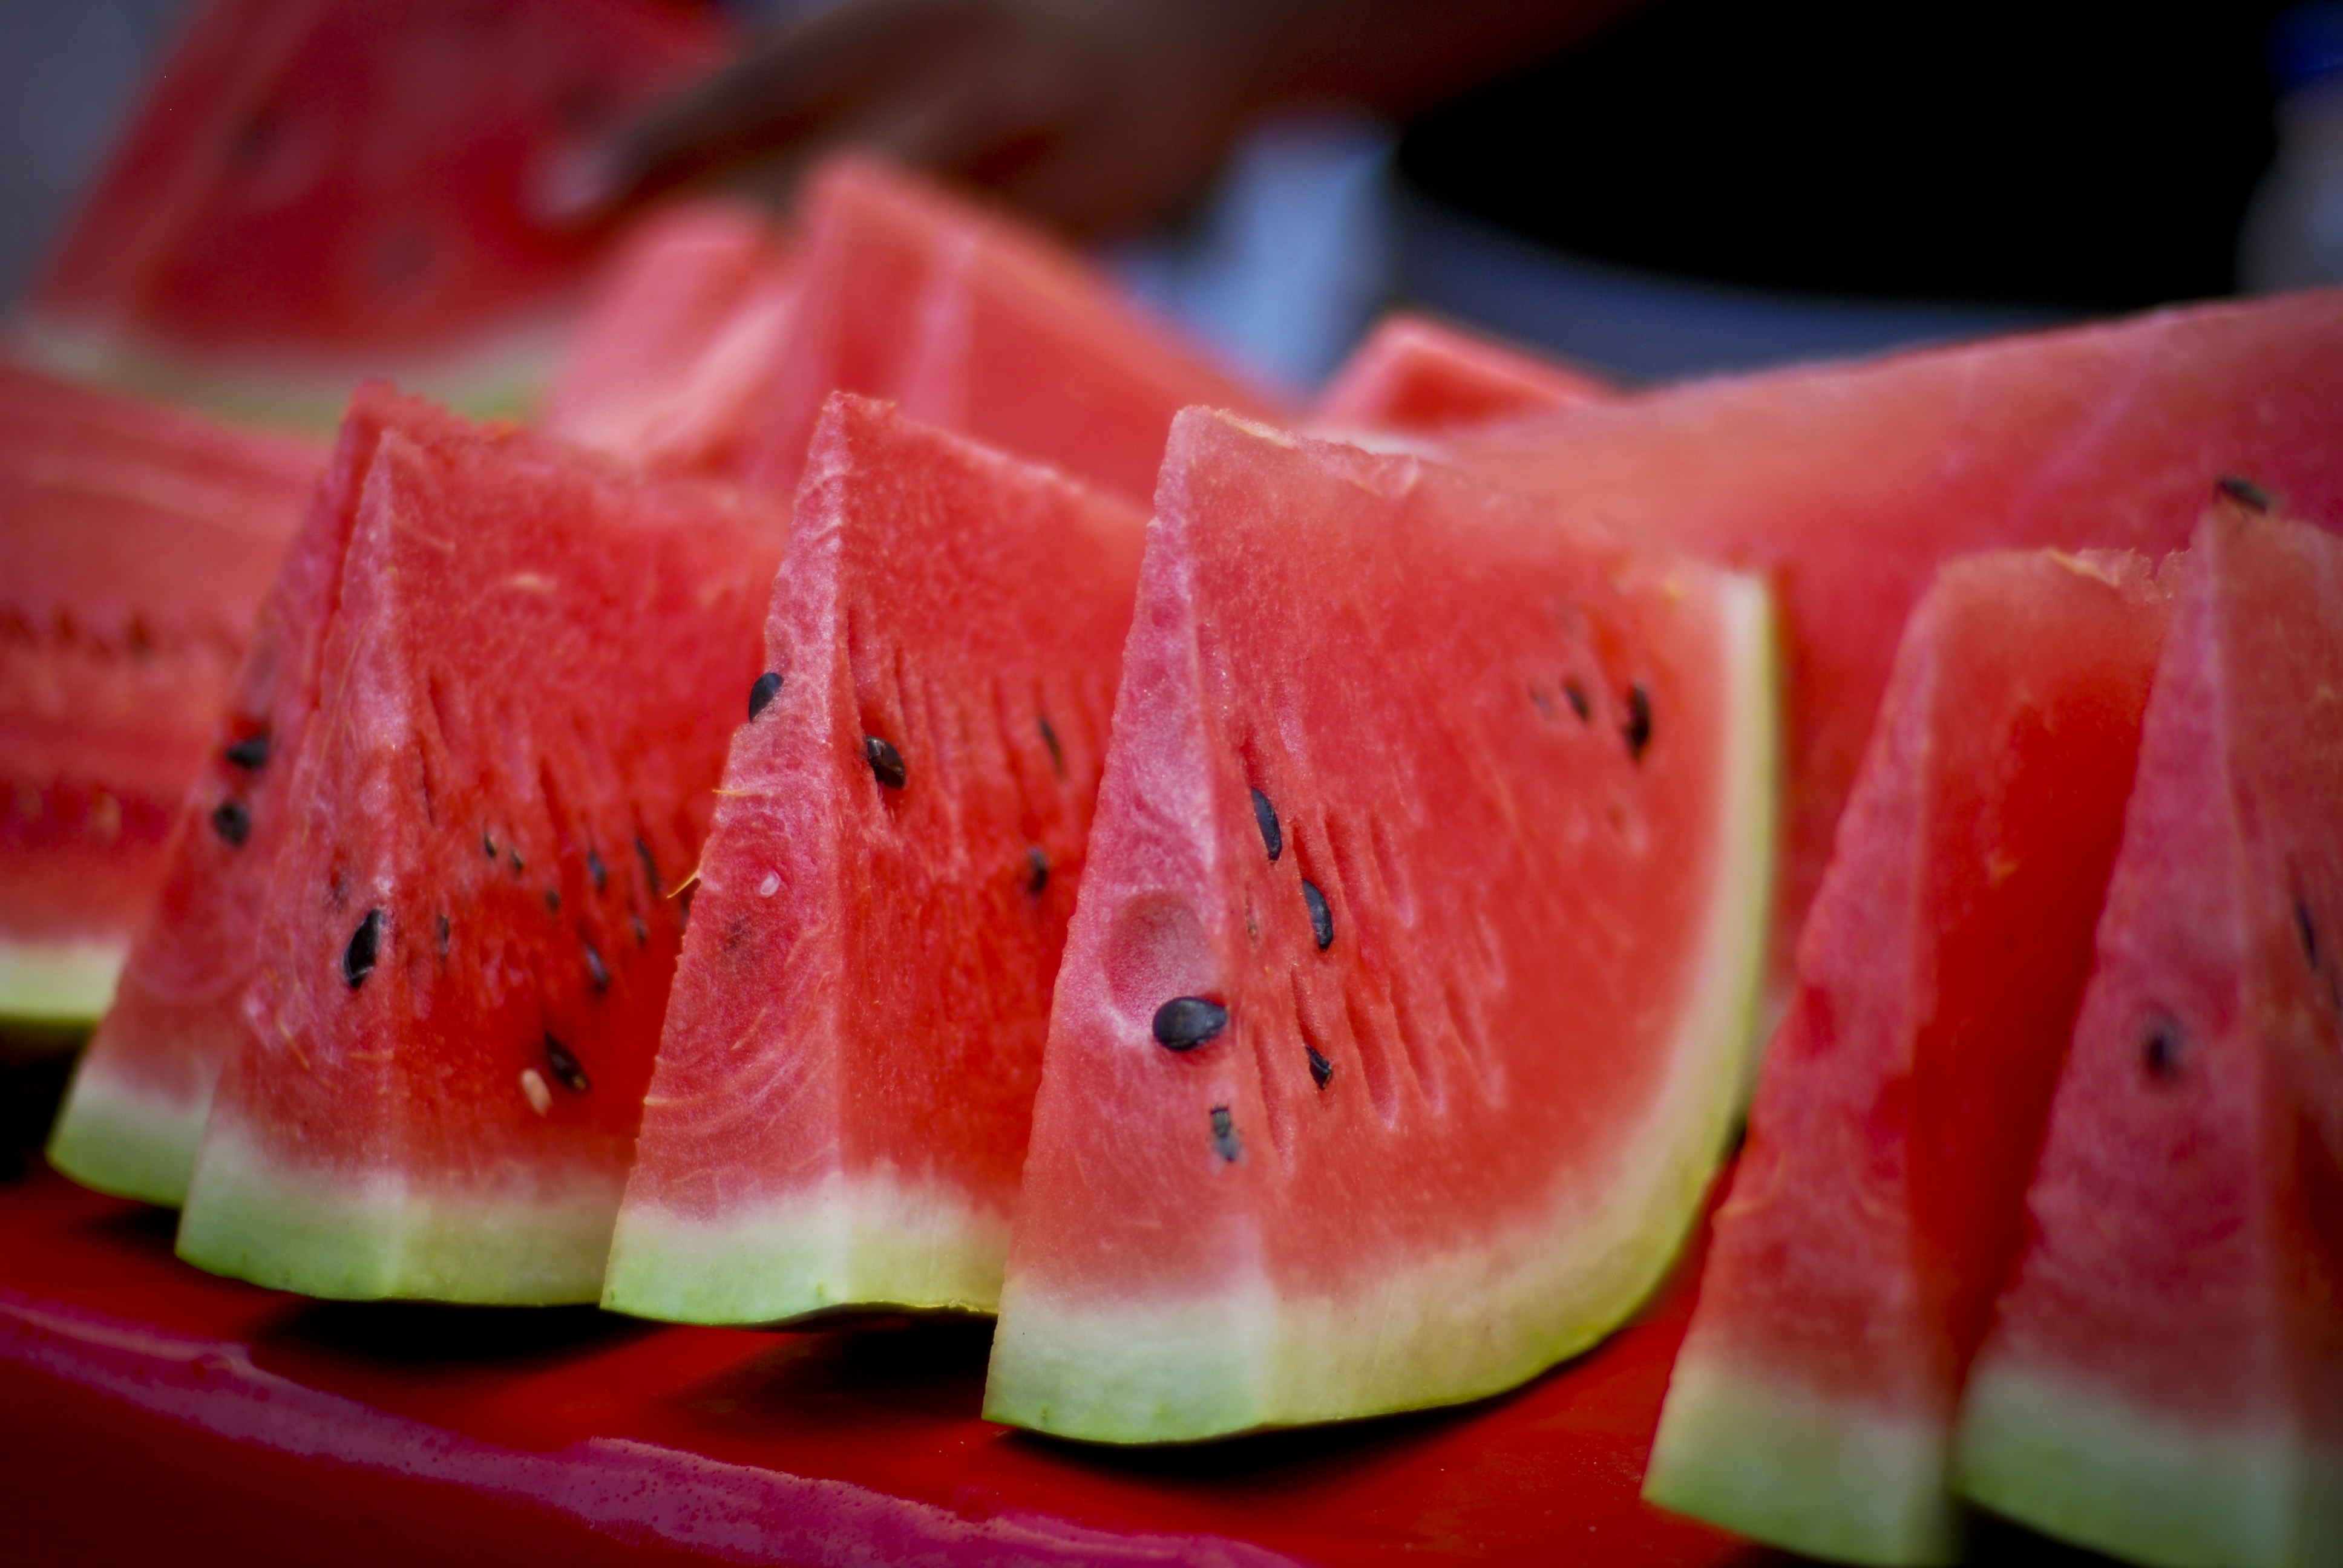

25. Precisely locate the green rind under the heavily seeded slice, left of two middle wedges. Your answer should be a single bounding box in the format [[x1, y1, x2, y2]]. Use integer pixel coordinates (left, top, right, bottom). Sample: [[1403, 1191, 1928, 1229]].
[[178, 1128, 618, 1305]]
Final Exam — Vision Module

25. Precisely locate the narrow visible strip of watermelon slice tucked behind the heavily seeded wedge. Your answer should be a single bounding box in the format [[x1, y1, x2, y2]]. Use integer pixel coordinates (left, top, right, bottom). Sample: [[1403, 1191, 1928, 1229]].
[[49, 384, 464, 1207]]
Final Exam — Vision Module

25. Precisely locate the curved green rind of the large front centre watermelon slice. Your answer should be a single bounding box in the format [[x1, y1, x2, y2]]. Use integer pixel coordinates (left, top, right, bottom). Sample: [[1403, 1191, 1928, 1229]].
[[984, 579, 1781, 1444]]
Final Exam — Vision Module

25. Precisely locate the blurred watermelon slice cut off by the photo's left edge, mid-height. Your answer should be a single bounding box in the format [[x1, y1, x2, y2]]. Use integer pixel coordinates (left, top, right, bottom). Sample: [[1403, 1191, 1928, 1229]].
[[0, 364, 323, 1024]]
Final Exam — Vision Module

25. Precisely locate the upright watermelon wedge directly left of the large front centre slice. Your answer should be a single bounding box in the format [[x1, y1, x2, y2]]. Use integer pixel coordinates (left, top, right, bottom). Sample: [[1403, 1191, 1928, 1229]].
[[602, 394, 1145, 1322]]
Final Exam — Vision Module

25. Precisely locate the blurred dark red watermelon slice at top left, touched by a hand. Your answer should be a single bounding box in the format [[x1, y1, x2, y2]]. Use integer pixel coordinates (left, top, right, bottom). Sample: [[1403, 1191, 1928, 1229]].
[[30, 0, 724, 424]]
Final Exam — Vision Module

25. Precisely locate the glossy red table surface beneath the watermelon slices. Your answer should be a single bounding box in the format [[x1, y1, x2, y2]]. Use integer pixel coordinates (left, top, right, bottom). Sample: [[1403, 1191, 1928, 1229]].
[[0, 1169, 2089, 1568]]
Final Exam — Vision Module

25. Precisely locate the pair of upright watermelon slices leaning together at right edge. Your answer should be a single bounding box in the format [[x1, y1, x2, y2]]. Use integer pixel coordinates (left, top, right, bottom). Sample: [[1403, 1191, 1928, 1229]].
[[1645, 483, 2343, 1568]]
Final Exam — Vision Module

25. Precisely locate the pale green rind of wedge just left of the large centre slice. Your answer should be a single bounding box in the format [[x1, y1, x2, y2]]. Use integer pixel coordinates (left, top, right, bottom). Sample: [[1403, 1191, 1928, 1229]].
[[602, 1174, 1010, 1324]]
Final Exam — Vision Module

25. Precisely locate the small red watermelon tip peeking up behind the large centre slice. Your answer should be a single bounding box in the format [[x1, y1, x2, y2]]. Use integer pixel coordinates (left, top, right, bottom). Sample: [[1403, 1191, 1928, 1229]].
[[1309, 312, 1617, 436]]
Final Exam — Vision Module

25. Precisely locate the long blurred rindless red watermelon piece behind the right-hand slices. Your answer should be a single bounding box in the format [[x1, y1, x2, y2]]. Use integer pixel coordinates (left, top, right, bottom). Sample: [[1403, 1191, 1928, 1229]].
[[1450, 290, 2343, 991]]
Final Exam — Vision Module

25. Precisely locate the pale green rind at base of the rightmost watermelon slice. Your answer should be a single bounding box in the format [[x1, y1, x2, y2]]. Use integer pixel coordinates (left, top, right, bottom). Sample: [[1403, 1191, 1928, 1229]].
[[1954, 1362, 2343, 1568]]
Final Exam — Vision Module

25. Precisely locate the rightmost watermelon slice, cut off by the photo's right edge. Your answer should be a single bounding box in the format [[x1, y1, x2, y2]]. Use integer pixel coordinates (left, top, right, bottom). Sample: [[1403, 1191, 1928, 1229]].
[[1959, 492, 2343, 1568]]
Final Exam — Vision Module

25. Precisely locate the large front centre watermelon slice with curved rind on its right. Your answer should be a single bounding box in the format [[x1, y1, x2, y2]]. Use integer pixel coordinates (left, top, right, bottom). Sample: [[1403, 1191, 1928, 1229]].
[[984, 410, 1774, 1442]]
